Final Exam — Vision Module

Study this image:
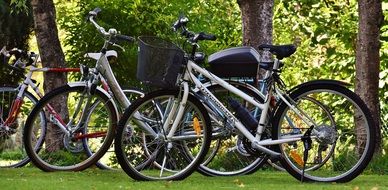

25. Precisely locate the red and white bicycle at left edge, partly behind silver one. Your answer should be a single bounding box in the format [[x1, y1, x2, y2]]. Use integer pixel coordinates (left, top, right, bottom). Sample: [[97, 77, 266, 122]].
[[0, 47, 79, 167]]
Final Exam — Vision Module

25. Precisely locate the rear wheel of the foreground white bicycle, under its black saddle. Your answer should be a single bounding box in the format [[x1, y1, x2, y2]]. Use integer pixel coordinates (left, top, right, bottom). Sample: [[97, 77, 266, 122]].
[[273, 84, 376, 182]]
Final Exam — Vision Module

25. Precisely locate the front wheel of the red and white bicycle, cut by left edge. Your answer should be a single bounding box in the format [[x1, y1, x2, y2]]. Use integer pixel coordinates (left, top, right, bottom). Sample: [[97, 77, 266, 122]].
[[0, 87, 46, 168]]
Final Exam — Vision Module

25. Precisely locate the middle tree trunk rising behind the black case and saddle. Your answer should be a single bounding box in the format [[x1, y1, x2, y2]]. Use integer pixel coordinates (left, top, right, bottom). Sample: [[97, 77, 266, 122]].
[[237, 0, 274, 79]]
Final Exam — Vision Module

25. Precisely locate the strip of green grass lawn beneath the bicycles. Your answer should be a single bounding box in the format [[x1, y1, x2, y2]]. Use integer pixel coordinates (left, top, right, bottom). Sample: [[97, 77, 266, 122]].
[[0, 167, 388, 190]]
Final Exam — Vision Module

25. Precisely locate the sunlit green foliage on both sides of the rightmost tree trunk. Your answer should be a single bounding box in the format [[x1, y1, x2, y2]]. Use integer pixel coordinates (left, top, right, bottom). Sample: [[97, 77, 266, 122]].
[[273, 0, 388, 137]]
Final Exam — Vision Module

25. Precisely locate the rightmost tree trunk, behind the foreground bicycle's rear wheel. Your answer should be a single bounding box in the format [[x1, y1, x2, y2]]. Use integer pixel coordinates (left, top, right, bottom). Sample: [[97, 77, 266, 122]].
[[355, 0, 384, 152]]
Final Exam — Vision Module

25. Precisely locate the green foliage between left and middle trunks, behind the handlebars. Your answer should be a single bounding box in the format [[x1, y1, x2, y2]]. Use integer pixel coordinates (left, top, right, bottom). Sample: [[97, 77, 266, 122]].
[[56, 0, 241, 86]]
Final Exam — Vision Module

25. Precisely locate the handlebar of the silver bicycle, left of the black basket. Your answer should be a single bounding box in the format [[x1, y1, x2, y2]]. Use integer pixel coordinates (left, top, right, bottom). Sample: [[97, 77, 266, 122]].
[[88, 8, 136, 43]]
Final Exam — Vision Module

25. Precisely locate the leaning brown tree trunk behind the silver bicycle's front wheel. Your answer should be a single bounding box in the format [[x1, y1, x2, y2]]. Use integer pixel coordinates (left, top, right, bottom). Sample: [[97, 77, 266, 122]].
[[31, 0, 68, 150]]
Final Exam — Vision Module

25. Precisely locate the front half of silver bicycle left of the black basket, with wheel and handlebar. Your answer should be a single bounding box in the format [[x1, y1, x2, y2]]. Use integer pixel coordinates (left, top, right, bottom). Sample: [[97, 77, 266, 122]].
[[23, 8, 142, 171]]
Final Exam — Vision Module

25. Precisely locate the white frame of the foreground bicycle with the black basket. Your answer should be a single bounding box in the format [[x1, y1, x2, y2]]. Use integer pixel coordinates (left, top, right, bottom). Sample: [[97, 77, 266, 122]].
[[165, 60, 316, 156]]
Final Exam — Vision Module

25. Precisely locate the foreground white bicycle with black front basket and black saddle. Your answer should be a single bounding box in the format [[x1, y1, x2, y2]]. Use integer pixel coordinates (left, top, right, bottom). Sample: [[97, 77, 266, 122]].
[[115, 15, 376, 182]]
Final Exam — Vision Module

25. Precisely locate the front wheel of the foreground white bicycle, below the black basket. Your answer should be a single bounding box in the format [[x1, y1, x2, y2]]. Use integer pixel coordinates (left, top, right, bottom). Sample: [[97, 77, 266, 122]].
[[115, 90, 211, 180]]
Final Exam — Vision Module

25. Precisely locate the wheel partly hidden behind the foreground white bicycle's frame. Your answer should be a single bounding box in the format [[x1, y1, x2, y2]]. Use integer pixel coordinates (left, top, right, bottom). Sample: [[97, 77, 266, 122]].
[[194, 81, 271, 176]]
